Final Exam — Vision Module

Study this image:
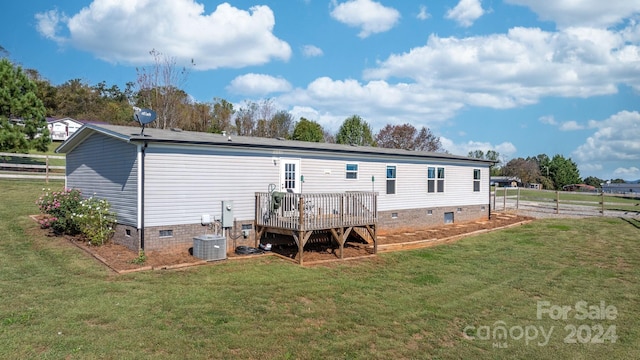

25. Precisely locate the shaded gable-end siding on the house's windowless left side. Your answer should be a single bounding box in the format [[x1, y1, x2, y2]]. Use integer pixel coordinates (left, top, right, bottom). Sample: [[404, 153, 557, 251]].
[[66, 134, 138, 226]]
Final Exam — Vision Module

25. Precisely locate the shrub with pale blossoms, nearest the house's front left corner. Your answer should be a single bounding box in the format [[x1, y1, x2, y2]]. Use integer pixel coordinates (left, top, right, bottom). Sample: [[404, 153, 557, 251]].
[[72, 197, 116, 245]]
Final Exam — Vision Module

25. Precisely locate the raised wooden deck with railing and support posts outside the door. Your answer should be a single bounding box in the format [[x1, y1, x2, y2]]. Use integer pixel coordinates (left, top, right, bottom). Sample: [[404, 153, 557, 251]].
[[255, 192, 378, 264]]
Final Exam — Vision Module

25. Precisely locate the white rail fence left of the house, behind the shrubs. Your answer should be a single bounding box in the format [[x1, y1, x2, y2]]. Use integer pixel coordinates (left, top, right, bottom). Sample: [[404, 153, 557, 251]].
[[0, 153, 65, 182]]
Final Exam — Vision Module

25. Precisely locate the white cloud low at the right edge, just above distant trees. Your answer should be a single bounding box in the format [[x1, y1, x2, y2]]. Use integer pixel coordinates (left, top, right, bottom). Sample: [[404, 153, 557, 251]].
[[573, 111, 640, 163]]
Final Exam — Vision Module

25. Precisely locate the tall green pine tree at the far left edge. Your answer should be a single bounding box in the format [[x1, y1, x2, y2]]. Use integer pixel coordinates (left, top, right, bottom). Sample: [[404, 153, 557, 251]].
[[0, 59, 51, 152]]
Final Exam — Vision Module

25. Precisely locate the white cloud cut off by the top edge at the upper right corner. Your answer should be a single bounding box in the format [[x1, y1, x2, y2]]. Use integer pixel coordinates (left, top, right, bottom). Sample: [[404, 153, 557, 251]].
[[506, 0, 640, 27]]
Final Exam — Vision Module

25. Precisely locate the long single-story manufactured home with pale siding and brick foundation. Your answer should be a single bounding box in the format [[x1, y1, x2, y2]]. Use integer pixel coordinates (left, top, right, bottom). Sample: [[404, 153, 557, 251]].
[[56, 124, 492, 250]]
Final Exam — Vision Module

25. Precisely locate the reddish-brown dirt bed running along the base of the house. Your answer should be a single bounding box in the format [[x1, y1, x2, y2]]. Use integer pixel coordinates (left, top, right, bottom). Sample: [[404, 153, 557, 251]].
[[34, 213, 533, 273]]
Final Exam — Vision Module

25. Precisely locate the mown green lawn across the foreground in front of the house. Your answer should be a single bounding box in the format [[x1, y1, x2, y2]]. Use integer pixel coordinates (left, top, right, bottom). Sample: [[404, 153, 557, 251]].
[[0, 180, 640, 359]]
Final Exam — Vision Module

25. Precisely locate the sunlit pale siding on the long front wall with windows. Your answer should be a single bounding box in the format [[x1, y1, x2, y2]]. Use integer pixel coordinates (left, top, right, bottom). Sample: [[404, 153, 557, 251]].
[[145, 144, 489, 226]]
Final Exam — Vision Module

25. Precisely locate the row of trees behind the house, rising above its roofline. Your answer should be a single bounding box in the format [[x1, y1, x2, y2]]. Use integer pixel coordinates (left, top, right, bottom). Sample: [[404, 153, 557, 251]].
[[0, 50, 446, 152]]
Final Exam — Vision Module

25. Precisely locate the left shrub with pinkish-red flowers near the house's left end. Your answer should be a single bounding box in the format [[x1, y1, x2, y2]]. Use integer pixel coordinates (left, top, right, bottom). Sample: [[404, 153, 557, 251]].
[[36, 188, 82, 235]]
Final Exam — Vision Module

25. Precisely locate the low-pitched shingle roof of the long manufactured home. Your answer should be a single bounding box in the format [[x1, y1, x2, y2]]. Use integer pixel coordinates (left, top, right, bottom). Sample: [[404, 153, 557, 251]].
[[56, 124, 493, 165]]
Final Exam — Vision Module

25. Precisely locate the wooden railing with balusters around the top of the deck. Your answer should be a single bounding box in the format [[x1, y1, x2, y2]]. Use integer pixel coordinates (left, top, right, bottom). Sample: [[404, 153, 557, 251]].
[[256, 192, 378, 231]]
